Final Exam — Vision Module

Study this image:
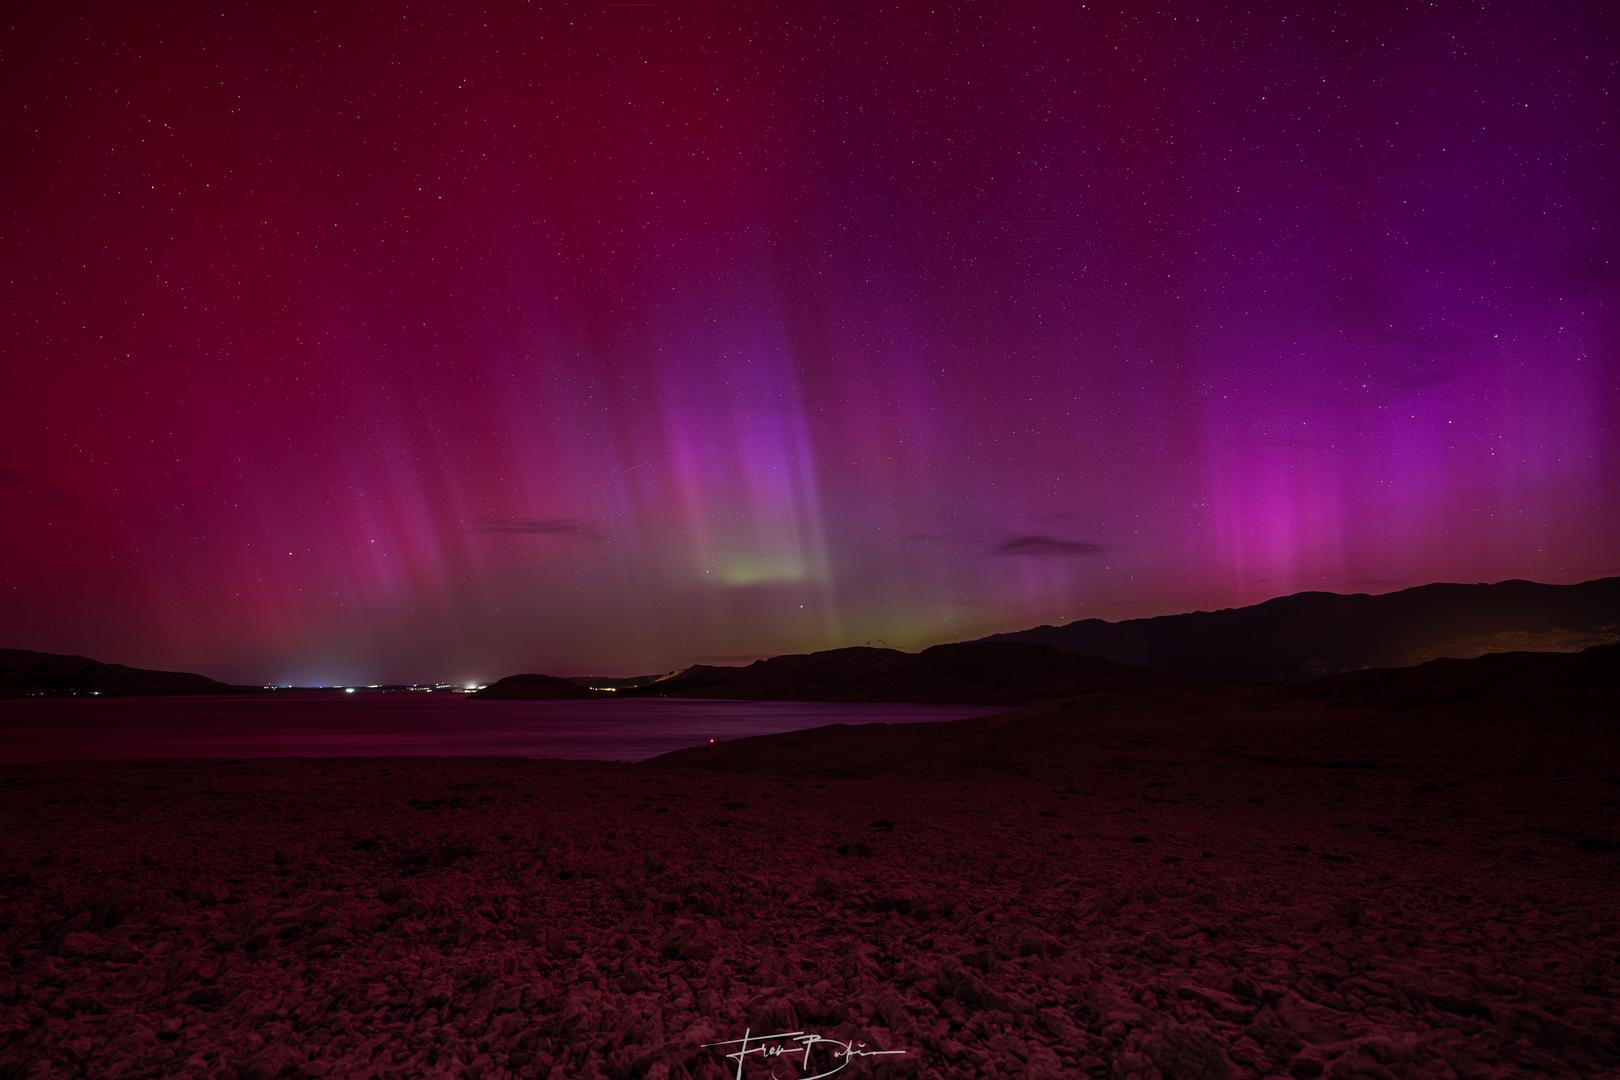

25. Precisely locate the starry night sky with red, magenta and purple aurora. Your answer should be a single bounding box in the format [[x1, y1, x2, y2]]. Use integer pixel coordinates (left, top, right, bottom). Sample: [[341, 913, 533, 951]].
[[0, 0, 1620, 683]]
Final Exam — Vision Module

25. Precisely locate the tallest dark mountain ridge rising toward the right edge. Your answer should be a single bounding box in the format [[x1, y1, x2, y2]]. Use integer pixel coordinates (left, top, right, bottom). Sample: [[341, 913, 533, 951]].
[[982, 578, 1620, 682]]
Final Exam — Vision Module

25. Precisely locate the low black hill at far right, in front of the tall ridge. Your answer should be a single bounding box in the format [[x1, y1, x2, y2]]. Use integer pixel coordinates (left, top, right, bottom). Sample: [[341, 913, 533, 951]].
[[1296, 644, 1620, 709]]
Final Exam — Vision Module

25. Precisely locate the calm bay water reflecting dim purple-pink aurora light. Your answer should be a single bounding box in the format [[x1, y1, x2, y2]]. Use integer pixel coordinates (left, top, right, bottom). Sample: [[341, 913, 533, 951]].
[[0, 693, 1004, 761]]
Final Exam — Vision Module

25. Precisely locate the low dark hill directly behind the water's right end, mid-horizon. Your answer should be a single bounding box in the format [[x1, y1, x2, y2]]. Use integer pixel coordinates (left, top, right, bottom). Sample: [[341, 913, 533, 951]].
[[620, 641, 1163, 704]]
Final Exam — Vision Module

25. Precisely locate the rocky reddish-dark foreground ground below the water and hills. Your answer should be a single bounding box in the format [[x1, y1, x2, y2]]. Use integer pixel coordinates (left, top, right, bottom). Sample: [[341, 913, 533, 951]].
[[0, 691, 1620, 1080]]
